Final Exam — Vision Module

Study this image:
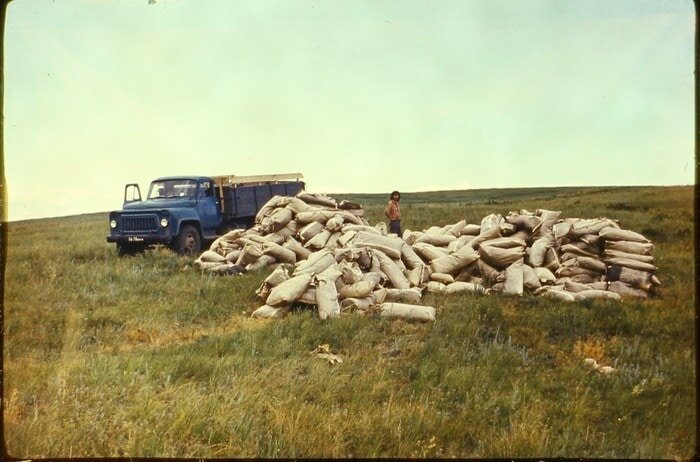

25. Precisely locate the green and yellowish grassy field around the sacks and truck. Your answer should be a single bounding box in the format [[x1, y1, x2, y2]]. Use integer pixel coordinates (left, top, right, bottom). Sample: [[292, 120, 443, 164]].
[[3, 187, 696, 459]]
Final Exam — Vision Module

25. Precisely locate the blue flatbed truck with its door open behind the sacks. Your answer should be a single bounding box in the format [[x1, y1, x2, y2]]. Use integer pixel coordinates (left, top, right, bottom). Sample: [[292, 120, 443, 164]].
[[107, 173, 305, 256]]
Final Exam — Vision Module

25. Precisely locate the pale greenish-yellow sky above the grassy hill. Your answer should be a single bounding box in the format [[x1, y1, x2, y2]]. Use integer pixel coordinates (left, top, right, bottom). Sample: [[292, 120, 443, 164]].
[[4, 0, 695, 220]]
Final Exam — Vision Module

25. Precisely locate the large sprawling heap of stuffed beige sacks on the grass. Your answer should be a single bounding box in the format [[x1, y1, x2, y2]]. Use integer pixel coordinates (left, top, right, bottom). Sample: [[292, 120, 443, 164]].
[[195, 192, 660, 320]]
